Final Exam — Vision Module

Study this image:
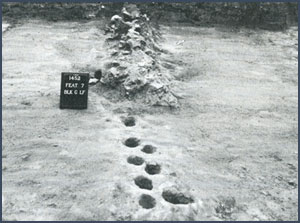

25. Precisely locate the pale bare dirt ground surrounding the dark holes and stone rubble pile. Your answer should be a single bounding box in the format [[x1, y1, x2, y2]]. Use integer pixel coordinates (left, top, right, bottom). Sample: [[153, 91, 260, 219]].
[[2, 20, 298, 220]]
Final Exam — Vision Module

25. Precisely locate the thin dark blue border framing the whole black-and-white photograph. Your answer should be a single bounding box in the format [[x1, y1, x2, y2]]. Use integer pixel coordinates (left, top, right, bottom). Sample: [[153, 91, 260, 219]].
[[0, 0, 300, 223]]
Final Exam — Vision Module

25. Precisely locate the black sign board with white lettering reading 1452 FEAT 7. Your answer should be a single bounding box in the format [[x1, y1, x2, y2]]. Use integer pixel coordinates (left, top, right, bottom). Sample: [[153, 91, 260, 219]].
[[60, 72, 89, 109]]
